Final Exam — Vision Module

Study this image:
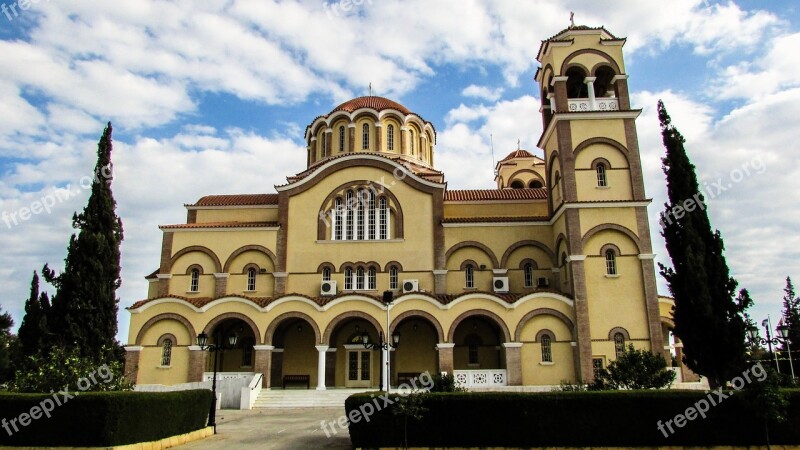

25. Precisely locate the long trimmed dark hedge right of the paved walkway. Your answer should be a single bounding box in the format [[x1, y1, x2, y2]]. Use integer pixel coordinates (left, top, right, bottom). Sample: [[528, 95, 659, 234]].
[[345, 390, 800, 448]]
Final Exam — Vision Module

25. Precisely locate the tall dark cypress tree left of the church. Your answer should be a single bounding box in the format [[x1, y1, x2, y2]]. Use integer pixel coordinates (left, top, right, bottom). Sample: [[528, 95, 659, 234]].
[[43, 122, 122, 356]]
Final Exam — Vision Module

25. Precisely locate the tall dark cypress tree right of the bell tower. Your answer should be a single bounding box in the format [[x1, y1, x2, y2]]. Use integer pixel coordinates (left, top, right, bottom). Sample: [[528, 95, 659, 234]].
[[658, 101, 752, 387]]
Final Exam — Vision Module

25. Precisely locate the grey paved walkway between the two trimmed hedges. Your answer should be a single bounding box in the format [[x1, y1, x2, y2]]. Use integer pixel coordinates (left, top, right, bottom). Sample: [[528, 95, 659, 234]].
[[180, 408, 352, 450]]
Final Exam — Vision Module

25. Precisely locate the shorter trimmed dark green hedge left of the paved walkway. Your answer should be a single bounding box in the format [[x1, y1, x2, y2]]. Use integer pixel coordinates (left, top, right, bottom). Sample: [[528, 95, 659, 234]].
[[0, 389, 211, 447]]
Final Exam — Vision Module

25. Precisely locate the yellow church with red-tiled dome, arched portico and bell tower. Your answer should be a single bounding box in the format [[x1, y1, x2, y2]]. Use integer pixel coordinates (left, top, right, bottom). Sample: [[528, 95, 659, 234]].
[[125, 26, 680, 390]]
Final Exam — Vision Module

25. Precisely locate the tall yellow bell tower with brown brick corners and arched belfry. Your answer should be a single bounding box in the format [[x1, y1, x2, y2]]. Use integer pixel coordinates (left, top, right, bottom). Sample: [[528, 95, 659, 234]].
[[536, 25, 665, 382]]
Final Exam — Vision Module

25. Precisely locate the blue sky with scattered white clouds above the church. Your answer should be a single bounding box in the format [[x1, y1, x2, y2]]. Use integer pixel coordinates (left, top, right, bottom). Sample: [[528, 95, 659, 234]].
[[0, 0, 800, 341]]
